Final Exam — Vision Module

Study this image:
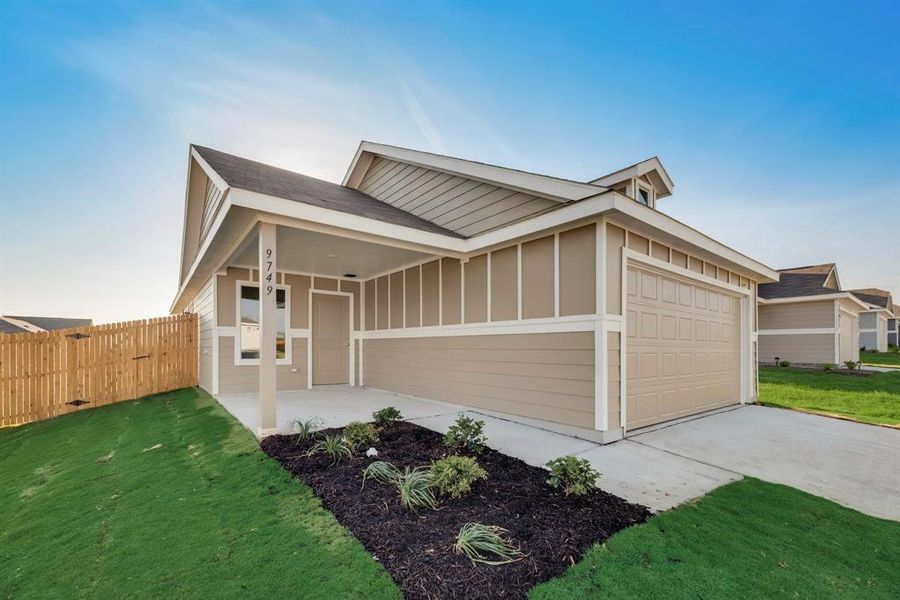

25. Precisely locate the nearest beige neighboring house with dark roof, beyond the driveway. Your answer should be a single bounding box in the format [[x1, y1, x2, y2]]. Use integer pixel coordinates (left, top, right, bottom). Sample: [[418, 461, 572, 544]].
[[759, 263, 868, 365]]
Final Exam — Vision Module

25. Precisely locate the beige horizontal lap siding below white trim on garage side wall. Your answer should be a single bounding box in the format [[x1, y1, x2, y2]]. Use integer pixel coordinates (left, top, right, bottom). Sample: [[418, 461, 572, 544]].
[[363, 332, 594, 428]]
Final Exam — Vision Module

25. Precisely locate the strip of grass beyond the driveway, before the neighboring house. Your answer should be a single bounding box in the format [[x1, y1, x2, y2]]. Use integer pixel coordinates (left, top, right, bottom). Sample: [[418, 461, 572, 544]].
[[759, 367, 900, 426]]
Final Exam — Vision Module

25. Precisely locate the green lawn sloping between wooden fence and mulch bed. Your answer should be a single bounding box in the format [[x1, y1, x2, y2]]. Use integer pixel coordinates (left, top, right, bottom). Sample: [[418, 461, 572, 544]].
[[0, 389, 400, 598]]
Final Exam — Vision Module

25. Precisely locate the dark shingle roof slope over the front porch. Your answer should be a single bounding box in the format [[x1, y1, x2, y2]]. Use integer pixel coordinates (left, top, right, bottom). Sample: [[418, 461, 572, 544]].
[[193, 145, 462, 237]]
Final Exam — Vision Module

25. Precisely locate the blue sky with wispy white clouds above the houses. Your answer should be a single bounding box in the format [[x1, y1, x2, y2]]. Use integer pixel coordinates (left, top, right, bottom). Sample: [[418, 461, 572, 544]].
[[0, 0, 900, 322]]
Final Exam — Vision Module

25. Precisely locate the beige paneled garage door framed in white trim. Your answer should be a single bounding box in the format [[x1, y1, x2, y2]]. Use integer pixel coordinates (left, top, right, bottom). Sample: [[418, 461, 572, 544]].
[[625, 266, 741, 430]]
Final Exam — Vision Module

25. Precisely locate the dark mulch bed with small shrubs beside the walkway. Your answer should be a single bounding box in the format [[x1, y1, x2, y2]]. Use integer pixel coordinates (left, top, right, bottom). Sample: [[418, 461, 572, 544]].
[[262, 423, 650, 598]]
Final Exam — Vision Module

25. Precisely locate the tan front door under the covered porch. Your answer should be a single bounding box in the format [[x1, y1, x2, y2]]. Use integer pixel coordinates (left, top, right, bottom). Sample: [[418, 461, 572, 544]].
[[312, 294, 350, 385]]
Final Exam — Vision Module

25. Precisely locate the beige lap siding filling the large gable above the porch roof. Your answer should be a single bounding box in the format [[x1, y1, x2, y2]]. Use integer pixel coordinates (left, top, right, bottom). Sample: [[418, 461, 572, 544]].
[[358, 156, 559, 237]]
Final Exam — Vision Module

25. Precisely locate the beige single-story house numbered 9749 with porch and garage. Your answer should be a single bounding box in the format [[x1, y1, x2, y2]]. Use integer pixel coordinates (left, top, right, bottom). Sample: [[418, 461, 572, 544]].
[[171, 142, 778, 442]]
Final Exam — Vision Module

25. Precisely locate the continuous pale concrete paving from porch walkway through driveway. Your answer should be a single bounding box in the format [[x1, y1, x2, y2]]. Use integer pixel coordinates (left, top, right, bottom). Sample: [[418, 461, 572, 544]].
[[218, 386, 900, 520]]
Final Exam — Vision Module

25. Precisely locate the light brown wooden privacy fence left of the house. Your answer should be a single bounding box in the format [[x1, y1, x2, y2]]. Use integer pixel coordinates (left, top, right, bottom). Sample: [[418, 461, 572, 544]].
[[0, 315, 198, 427]]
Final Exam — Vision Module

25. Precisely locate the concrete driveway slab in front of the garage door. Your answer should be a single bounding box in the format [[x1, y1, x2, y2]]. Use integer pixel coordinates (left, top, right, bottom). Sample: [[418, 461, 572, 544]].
[[629, 406, 900, 520]]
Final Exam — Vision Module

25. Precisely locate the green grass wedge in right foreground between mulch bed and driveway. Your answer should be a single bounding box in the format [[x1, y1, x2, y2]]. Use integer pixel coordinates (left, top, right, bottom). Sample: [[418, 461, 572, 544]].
[[531, 479, 900, 600]]
